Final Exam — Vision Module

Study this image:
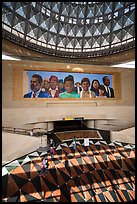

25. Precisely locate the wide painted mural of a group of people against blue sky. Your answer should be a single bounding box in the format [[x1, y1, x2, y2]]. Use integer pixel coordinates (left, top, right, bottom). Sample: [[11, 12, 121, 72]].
[[22, 70, 115, 99]]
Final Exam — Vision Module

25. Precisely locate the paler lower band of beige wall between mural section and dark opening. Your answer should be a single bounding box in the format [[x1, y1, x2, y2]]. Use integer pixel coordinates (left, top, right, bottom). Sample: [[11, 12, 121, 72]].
[[2, 105, 135, 129]]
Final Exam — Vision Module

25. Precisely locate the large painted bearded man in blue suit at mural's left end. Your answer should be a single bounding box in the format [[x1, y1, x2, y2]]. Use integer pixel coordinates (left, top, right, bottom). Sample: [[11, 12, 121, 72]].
[[24, 74, 51, 98]]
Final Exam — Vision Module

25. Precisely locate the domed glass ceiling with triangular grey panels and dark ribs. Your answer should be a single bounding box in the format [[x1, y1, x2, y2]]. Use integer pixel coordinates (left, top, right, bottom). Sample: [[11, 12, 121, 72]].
[[2, 2, 135, 58]]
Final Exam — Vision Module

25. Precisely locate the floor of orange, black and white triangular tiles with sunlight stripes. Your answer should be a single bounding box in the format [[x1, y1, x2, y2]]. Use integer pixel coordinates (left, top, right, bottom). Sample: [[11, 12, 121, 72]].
[[2, 141, 135, 202]]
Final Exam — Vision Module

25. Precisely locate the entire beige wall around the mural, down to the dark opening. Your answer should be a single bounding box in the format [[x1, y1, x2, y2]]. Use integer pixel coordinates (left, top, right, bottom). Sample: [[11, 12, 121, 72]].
[[2, 61, 135, 131]]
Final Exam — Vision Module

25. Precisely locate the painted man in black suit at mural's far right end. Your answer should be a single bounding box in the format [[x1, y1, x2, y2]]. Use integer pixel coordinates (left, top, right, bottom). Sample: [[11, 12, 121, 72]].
[[102, 76, 115, 98]]
